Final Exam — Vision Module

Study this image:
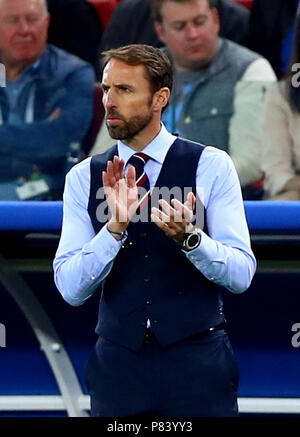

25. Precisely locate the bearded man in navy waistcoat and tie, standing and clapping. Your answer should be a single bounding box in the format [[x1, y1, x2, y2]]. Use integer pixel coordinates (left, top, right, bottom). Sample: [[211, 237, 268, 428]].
[[54, 45, 256, 417]]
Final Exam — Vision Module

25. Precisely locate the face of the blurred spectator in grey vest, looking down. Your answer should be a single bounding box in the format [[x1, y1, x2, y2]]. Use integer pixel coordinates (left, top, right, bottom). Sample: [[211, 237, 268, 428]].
[[155, 0, 219, 71]]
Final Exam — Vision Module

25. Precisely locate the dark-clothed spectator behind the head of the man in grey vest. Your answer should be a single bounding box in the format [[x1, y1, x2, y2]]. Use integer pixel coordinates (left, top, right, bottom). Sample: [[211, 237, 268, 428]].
[[101, 0, 250, 50]]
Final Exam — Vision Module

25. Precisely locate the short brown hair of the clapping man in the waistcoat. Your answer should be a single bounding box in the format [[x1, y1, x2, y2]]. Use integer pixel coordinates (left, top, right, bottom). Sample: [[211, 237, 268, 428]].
[[102, 44, 173, 94]]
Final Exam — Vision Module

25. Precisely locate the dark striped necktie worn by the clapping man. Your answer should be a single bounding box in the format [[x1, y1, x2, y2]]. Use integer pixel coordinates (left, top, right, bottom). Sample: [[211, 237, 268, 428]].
[[128, 152, 150, 212]]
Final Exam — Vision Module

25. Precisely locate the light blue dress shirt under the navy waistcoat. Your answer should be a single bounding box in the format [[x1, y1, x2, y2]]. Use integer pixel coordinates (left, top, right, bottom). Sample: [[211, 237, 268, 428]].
[[53, 125, 256, 306]]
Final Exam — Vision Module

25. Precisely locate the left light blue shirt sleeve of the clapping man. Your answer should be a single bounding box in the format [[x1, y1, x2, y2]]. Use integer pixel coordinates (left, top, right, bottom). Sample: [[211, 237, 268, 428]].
[[53, 160, 122, 306]]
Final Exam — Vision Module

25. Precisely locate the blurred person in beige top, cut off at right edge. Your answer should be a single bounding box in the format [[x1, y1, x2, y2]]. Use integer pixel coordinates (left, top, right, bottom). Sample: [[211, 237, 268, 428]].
[[262, 18, 300, 200]]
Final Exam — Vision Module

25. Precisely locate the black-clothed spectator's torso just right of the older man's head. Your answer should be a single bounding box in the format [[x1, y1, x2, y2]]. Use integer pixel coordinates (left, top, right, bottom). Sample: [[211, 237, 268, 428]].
[[47, 0, 102, 76]]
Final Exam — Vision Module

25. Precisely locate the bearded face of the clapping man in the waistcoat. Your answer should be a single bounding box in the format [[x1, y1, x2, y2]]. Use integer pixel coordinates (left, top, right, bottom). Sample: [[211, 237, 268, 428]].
[[102, 59, 153, 140]]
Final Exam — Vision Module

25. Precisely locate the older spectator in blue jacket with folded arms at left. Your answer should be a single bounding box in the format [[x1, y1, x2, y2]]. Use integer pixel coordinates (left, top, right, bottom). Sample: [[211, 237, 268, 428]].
[[0, 0, 94, 200]]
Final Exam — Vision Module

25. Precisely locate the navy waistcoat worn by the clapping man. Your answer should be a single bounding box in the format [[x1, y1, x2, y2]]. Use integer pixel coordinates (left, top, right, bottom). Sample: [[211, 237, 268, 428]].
[[88, 138, 224, 351]]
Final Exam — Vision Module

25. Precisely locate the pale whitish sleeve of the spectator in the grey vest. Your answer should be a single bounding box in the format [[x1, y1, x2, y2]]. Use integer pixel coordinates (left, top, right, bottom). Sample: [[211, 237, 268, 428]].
[[229, 58, 276, 186]]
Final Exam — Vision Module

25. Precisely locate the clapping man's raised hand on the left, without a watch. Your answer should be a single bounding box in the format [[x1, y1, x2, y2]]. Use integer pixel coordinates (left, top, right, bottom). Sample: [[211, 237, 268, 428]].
[[102, 156, 138, 232]]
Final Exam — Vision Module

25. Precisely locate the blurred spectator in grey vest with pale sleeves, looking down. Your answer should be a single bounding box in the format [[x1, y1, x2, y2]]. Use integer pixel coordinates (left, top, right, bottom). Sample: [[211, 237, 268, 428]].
[[93, 0, 276, 199]]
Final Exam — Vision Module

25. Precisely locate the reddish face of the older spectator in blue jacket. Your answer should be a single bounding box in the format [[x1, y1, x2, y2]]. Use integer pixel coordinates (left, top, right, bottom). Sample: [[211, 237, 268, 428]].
[[0, 0, 50, 65]]
